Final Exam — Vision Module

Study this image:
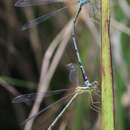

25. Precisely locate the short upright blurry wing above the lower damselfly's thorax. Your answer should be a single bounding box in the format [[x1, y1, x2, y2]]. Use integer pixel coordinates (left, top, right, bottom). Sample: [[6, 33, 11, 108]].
[[67, 63, 79, 86]]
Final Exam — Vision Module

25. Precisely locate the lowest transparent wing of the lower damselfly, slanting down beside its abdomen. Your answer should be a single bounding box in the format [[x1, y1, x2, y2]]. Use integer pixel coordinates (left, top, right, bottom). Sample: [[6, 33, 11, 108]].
[[23, 92, 75, 124]]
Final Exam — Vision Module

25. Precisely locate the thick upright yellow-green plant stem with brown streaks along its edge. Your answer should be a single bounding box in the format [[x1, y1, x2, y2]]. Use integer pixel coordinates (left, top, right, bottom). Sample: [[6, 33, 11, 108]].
[[100, 0, 114, 130]]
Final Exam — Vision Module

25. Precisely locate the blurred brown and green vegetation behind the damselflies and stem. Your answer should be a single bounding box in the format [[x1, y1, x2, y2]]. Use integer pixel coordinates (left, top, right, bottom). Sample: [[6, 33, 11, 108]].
[[0, 0, 130, 130]]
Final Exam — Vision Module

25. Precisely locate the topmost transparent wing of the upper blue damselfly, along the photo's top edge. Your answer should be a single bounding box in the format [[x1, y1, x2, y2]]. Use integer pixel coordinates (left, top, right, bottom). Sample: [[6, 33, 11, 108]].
[[15, 0, 77, 7]]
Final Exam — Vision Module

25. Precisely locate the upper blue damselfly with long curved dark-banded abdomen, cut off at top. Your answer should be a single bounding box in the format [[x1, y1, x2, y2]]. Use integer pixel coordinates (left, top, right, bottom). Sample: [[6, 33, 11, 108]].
[[15, 0, 99, 86]]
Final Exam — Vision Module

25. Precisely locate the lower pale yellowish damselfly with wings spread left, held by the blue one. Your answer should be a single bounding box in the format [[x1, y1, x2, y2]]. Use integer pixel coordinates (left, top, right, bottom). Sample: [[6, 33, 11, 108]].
[[12, 64, 98, 130]]
